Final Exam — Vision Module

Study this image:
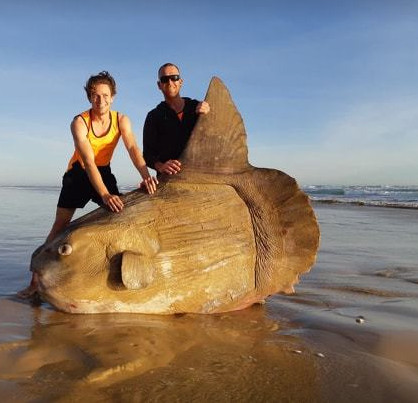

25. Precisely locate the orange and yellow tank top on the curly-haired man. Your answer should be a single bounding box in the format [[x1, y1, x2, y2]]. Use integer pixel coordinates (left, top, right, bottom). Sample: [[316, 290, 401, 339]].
[[67, 110, 120, 170]]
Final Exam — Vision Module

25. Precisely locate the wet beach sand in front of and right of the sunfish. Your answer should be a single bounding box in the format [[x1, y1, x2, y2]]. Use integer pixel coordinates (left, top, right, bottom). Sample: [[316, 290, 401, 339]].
[[0, 204, 418, 403]]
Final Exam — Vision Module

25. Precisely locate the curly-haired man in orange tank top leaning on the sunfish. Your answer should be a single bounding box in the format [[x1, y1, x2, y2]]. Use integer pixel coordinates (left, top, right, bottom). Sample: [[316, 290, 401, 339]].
[[18, 71, 158, 298]]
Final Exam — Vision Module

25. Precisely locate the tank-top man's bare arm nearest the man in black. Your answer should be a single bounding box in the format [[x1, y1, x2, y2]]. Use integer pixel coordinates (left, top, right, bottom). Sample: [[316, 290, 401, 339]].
[[119, 114, 158, 193]]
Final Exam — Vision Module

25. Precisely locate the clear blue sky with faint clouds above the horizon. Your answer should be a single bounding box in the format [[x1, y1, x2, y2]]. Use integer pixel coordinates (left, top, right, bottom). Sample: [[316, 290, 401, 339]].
[[0, 0, 418, 186]]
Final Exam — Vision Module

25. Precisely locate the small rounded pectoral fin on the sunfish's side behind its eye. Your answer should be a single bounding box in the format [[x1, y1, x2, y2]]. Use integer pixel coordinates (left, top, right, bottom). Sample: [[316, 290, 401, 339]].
[[121, 251, 154, 290]]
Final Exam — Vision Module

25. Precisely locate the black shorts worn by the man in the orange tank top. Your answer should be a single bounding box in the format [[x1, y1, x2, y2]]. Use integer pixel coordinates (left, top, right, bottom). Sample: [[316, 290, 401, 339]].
[[58, 162, 120, 208]]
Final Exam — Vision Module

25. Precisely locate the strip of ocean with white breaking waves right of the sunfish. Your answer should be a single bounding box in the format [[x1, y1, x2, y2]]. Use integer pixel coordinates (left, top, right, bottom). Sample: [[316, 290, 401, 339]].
[[303, 185, 418, 208]]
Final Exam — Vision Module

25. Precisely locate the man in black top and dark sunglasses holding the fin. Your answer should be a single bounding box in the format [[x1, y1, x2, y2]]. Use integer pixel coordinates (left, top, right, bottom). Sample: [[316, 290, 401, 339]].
[[144, 63, 210, 175]]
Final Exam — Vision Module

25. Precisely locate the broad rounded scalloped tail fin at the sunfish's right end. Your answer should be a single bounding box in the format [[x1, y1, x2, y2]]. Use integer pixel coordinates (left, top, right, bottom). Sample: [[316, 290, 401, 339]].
[[232, 168, 320, 297]]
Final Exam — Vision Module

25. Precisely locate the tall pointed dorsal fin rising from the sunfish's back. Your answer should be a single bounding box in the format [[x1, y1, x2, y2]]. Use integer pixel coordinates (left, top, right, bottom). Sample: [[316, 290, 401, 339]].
[[180, 77, 250, 174]]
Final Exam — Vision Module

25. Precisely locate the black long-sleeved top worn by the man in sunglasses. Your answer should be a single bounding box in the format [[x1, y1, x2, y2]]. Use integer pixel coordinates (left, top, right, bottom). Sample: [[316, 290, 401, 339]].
[[143, 98, 198, 169]]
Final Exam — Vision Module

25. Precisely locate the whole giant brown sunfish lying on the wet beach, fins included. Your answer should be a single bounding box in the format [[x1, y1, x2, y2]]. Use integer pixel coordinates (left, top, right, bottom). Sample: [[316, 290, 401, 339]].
[[31, 77, 319, 314]]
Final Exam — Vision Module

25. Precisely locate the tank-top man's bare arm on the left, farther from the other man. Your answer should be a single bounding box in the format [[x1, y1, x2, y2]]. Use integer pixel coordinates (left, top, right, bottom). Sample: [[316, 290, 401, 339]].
[[71, 116, 123, 212]]
